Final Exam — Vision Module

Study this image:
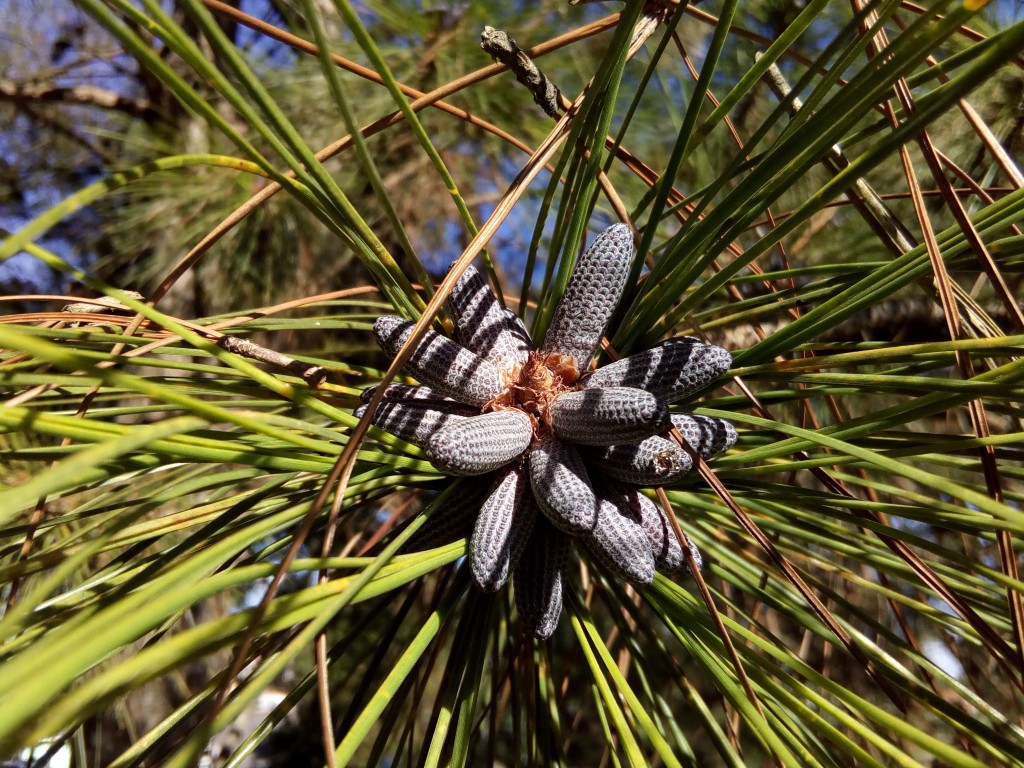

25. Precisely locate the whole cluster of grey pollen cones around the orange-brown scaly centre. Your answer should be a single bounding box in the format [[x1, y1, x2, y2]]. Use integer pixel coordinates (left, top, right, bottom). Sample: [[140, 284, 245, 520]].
[[356, 224, 736, 638]]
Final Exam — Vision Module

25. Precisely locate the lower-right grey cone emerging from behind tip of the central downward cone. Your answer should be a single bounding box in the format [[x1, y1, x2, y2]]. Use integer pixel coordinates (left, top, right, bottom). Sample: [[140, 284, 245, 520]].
[[583, 494, 654, 587]]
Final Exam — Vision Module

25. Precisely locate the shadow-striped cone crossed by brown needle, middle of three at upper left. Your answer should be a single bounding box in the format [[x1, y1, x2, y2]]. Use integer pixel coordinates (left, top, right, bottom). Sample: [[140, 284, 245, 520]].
[[374, 315, 504, 408]]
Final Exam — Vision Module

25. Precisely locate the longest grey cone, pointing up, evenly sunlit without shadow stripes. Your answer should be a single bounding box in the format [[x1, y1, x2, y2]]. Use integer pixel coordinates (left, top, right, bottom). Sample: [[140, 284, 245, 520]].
[[542, 224, 633, 371]]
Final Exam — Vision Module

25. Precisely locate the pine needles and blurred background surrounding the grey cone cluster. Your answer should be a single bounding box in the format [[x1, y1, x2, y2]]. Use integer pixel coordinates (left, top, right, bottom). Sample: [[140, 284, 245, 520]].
[[0, 0, 1024, 766]]
